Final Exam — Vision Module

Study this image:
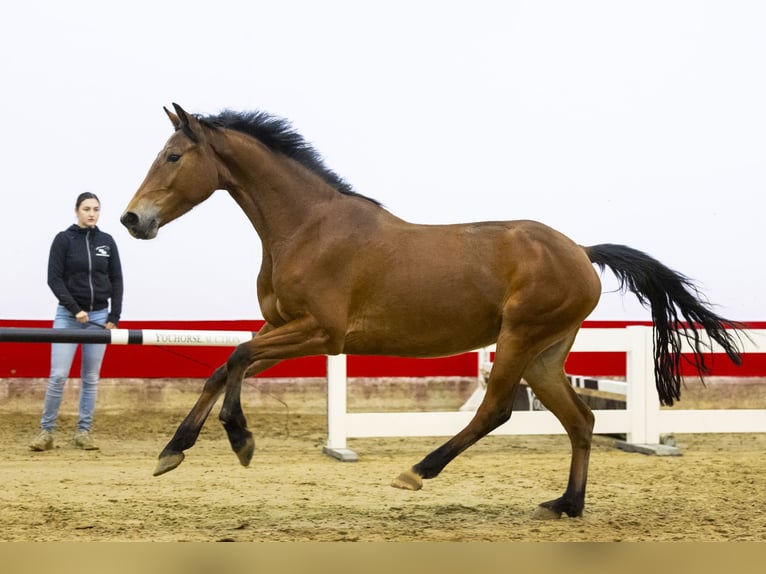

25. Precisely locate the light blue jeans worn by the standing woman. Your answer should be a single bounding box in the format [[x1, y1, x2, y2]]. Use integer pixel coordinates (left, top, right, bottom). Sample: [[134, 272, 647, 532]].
[[40, 305, 109, 432]]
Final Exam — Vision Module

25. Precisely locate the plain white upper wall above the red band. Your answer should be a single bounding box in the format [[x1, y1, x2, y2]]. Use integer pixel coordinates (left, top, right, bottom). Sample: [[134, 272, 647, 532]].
[[0, 0, 766, 321]]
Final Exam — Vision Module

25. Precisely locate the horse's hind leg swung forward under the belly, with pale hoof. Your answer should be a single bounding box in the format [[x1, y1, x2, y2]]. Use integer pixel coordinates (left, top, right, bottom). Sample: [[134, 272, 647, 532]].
[[391, 344, 526, 490]]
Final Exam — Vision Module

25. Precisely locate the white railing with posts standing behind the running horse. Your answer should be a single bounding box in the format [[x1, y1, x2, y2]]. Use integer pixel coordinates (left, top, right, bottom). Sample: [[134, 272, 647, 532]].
[[324, 326, 766, 460]]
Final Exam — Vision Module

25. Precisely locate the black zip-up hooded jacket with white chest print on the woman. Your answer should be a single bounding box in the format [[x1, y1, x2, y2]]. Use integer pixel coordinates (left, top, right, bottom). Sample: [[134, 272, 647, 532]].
[[48, 224, 122, 325]]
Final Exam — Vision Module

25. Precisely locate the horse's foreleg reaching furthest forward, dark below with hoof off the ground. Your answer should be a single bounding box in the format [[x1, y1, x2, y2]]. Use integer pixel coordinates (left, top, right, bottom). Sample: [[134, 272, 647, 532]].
[[154, 365, 226, 476]]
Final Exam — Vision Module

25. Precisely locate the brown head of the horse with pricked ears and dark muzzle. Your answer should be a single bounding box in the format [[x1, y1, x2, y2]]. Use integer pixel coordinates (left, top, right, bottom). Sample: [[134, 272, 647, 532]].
[[120, 103, 220, 239]]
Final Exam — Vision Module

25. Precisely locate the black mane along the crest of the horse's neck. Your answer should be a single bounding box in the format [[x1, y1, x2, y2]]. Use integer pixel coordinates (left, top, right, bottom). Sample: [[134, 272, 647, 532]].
[[197, 110, 380, 205]]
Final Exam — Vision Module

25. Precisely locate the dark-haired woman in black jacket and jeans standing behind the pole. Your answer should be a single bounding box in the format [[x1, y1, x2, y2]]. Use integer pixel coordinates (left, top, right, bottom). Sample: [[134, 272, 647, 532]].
[[29, 192, 122, 451]]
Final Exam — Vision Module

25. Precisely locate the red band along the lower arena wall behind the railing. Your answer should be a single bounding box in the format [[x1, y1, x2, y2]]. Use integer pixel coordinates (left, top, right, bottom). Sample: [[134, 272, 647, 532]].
[[0, 319, 766, 378]]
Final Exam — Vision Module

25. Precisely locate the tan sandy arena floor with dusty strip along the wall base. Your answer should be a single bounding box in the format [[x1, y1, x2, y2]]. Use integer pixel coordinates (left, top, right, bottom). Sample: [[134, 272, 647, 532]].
[[0, 379, 766, 541]]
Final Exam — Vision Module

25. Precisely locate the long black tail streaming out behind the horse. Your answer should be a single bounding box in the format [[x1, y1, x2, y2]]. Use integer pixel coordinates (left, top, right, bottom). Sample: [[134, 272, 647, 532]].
[[584, 244, 741, 405]]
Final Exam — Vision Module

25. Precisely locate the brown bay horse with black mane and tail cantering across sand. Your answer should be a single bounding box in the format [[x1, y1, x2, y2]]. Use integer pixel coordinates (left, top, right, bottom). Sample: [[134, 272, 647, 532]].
[[121, 104, 739, 517]]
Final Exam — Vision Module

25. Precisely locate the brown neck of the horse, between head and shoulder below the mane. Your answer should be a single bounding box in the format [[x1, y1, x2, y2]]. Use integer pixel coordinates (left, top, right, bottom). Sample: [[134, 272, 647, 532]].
[[216, 132, 339, 247]]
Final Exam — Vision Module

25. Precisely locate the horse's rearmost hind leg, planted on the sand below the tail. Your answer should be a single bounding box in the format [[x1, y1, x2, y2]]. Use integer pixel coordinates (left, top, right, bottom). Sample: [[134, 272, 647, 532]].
[[524, 336, 594, 519]]
